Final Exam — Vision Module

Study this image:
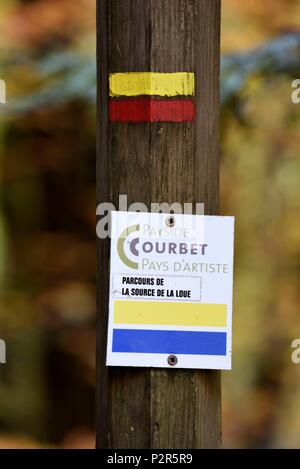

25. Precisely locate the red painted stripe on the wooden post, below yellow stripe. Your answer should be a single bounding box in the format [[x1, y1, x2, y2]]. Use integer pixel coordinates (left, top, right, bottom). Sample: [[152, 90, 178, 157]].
[[109, 98, 196, 122]]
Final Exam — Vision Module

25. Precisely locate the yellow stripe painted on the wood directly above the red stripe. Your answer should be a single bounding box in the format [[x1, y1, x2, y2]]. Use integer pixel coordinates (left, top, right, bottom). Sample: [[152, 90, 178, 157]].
[[109, 72, 195, 97]]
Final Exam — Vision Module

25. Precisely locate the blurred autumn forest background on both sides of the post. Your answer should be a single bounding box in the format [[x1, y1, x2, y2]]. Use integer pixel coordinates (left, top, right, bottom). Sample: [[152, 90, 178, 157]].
[[0, 0, 300, 448]]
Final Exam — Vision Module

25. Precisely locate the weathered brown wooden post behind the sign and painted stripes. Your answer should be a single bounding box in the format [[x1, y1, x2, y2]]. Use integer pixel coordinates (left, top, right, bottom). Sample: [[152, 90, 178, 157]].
[[96, 0, 221, 449]]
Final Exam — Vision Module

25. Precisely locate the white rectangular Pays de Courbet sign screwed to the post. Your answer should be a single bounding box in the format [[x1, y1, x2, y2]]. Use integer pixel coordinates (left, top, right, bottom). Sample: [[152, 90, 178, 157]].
[[107, 212, 234, 369]]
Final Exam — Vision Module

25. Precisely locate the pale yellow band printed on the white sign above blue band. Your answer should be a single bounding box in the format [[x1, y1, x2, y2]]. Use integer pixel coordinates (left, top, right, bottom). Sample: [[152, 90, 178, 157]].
[[114, 300, 227, 327]]
